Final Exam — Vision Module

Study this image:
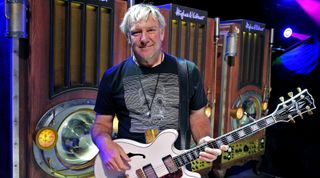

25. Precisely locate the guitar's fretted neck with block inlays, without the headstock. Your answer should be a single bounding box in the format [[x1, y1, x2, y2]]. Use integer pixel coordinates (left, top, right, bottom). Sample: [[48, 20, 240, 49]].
[[173, 114, 277, 167]]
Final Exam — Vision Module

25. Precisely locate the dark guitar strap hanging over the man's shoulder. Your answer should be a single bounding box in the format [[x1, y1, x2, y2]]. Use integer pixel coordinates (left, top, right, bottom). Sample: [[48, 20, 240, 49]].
[[177, 58, 191, 150]]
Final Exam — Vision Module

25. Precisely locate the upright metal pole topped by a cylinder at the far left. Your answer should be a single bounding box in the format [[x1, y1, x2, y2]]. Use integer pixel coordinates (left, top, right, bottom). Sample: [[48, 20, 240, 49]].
[[4, 0, 28, 178]]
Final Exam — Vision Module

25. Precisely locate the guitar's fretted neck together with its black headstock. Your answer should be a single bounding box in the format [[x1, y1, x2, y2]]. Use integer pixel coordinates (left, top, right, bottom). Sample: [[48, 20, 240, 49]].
[[173, 89, 316, 167]]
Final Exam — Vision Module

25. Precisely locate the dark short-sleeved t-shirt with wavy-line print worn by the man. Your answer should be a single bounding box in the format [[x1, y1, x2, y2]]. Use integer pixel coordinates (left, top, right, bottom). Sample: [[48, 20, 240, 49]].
[[94, 54, 207, 143]]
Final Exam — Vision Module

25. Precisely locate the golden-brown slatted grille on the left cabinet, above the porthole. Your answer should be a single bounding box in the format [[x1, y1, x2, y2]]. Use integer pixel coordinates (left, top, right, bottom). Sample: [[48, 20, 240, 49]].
[[50, 0, 114, 96]]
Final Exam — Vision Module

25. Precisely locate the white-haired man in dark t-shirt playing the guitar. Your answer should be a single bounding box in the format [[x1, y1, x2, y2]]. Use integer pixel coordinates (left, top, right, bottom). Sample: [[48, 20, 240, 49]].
[[91, 4, 227, 174]]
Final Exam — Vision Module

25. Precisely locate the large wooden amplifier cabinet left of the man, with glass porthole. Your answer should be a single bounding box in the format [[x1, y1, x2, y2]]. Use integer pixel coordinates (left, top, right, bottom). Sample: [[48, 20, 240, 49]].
[[18, 0, 129, 178]]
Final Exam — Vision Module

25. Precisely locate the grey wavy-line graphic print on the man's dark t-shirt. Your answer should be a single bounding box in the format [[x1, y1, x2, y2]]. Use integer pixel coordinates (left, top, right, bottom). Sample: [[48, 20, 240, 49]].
[[123, 73, 179, 133]]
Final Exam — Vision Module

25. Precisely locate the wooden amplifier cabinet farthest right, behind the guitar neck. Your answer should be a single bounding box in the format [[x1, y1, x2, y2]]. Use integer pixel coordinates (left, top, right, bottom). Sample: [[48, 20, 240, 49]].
[[213, 19, 270, 168]]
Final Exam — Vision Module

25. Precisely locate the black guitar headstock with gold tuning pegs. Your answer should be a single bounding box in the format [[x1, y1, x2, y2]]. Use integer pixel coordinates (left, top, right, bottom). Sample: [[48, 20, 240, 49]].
[[272, 88, 316, 122]]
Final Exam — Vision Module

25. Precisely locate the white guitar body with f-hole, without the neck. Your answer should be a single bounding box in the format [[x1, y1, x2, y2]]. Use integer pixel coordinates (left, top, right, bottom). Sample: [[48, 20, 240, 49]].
[[94, 129, 201, 178]]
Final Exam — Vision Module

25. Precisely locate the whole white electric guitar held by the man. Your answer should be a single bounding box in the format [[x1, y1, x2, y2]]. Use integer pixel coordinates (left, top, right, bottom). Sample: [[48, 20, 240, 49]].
[[94, 89, 316, 178]]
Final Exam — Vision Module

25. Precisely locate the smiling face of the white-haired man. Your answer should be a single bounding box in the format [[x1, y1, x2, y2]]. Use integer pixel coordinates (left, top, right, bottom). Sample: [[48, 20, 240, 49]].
[[129, 15, 164, 62]]
